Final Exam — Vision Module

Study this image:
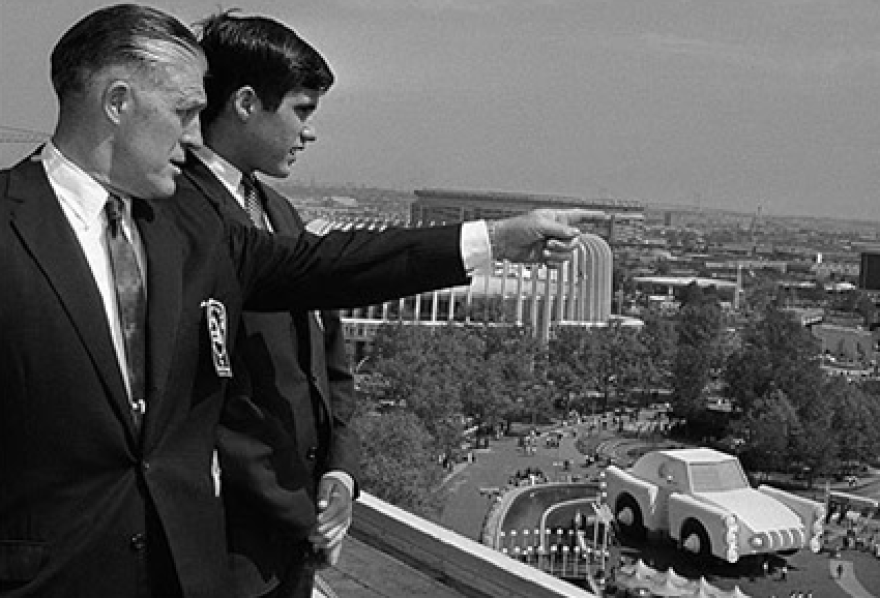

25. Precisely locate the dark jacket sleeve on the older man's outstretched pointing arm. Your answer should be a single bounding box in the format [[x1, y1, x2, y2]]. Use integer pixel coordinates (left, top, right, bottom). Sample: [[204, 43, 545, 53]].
[[225, 221, 470, 311]]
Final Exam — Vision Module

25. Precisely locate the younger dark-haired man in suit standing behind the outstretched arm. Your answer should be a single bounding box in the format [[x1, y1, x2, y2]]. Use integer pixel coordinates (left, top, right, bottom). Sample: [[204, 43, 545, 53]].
[[185, 12, 360, 598]]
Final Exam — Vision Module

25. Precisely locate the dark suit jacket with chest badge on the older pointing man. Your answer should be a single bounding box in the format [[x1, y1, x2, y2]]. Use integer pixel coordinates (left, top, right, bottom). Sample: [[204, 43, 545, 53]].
[[0, 154, 466, 598]]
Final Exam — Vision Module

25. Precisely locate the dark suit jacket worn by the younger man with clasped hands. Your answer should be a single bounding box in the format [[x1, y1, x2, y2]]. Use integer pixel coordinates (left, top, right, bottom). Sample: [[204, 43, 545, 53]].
[[184, 159, 360, 596]]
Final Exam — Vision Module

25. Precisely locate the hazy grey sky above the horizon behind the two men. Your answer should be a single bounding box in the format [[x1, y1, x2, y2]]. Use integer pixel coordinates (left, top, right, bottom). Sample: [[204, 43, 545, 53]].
[[0, 0, 880, 221]]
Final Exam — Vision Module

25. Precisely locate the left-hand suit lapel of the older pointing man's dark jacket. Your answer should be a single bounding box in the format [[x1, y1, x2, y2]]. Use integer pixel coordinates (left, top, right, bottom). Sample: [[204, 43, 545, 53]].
[[9, 159, 134, 439]]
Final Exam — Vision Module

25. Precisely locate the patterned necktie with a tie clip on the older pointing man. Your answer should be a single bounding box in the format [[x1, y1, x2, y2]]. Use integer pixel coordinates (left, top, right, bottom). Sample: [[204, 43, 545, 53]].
[[104, 194, 147, 428]]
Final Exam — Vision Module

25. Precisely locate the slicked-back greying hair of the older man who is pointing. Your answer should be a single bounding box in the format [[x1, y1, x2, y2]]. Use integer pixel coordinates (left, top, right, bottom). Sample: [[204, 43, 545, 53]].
[[51, 4, 202, 102]]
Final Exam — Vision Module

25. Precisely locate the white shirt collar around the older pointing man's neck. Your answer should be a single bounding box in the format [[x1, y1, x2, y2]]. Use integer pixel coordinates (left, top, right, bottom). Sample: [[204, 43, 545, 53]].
[[40, 141, 118, 228]]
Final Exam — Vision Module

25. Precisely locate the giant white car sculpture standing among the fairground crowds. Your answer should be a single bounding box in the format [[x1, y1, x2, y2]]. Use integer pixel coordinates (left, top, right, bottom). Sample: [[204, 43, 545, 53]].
[[604, 448, 825, 563]]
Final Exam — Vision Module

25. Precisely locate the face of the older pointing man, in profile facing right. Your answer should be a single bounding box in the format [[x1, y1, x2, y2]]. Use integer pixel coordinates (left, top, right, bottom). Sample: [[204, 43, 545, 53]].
[[108, 57, 206, 198]]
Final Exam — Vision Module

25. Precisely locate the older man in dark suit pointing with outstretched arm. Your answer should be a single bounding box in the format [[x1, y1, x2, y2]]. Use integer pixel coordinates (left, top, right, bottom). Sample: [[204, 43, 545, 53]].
[[0, 5, 600, 598]]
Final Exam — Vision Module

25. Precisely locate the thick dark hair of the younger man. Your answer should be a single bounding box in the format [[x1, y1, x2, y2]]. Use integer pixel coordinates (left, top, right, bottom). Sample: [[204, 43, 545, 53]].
[[197, 10, 333, 126]]
